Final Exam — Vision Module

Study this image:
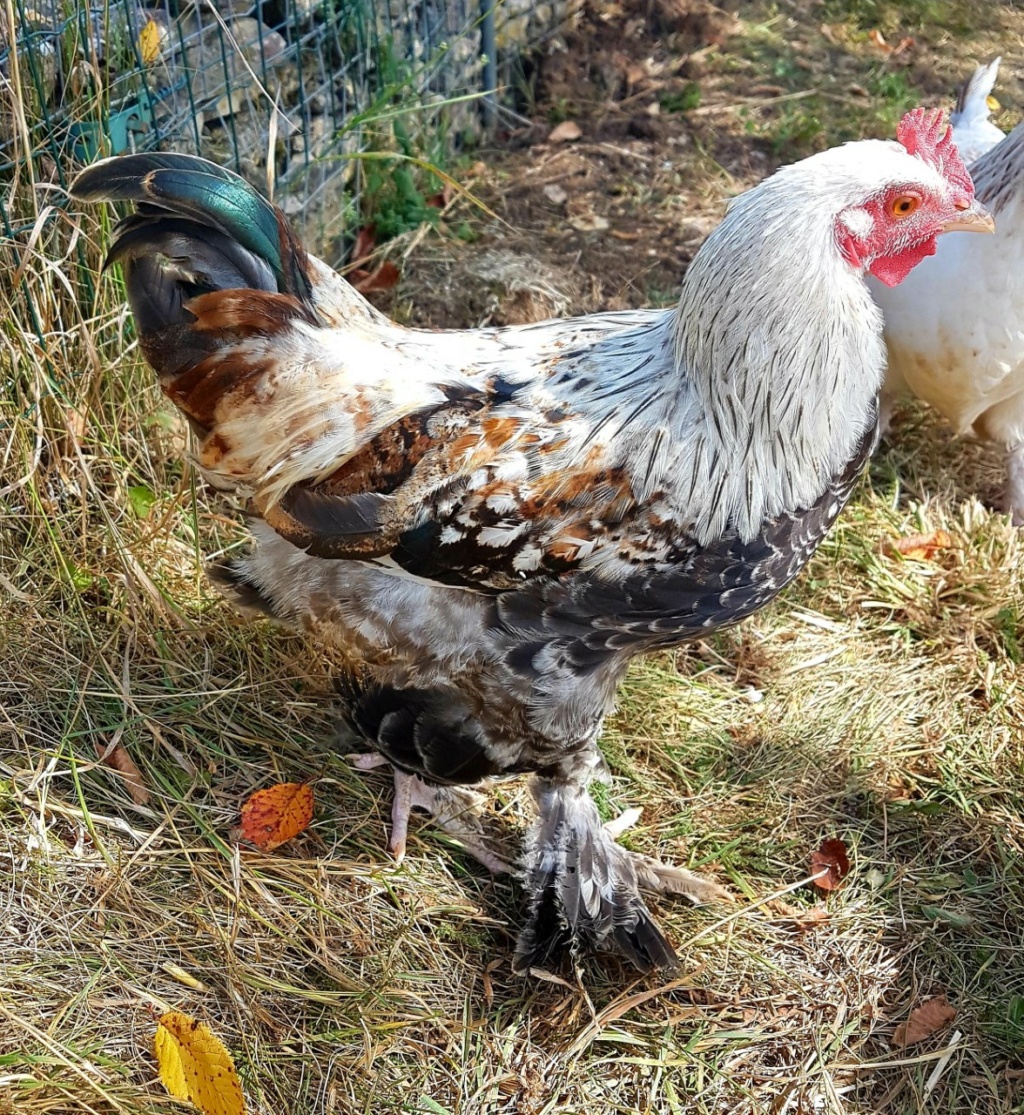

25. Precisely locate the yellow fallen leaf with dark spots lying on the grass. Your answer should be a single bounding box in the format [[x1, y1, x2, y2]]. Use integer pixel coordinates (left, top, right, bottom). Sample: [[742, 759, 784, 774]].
[[153, 1010, 245, 1115]]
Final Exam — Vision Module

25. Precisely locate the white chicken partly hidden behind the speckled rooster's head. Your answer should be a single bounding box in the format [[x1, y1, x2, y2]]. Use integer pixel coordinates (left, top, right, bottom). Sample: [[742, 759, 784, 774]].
[[870, 59, 1024, 526]]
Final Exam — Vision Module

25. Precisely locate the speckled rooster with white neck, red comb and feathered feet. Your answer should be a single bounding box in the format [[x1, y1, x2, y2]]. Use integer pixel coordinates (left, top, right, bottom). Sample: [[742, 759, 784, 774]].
[[73, 109, 991, 971]]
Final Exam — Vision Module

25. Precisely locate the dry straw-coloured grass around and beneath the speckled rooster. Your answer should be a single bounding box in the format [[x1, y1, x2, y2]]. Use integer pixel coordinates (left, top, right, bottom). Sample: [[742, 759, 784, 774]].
[[0, 2, 1024, 1115]]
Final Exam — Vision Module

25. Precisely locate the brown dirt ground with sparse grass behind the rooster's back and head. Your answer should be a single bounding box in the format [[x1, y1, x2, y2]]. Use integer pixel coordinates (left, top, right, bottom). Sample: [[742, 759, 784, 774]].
[[381, 0, 1024, 341]]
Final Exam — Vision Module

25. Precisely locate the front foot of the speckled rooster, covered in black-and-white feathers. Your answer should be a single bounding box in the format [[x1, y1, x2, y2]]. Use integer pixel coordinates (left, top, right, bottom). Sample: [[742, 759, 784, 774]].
[[514, 778, 731, 972]]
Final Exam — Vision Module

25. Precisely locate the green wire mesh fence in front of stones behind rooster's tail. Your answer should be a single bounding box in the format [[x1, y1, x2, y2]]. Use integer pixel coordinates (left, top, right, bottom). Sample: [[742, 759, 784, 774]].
[[0, 0, 577, 253]]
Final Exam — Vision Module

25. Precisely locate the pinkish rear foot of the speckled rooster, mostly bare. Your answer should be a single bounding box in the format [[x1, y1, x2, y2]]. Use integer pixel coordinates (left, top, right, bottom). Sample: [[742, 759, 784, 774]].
[[349, 752, 513, 874]]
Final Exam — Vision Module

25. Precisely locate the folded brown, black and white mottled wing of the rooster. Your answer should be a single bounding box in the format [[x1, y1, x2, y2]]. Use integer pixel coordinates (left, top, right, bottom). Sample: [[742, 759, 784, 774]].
[[258, 399, 657, 590]]
